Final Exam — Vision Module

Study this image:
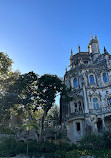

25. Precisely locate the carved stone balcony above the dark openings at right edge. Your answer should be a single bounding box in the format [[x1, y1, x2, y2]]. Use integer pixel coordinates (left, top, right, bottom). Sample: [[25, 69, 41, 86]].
[[89, 106, 111, 114]]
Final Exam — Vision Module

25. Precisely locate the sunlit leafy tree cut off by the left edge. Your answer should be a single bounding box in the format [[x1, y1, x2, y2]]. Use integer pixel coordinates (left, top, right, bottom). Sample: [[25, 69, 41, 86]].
[[0, 52, 20, 123]]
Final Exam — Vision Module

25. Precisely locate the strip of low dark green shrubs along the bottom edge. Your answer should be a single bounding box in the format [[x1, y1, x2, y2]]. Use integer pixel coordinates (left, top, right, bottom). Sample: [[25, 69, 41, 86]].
[[0, 138, 111, 158]]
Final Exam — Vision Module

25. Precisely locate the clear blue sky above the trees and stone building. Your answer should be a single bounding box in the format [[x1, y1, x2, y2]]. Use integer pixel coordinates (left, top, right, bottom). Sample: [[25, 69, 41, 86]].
[[0, 0, 111, 106]]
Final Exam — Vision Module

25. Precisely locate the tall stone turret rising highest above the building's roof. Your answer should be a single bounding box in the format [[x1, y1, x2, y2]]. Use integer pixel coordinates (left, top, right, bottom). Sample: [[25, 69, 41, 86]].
[[88, 35, 100, 61]]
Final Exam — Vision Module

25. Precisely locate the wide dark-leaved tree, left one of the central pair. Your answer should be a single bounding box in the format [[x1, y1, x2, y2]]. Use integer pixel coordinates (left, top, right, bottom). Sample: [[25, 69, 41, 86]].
[[2, 72, 38, 140]]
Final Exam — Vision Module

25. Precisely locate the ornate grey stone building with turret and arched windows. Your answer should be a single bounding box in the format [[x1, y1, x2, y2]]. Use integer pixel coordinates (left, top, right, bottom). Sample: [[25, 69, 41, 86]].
[[61, 36, 111, 142]]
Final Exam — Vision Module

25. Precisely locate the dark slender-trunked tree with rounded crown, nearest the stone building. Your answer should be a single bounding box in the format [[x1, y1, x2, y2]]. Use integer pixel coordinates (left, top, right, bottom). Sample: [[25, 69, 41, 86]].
[[35, 74, 65, 141]]
